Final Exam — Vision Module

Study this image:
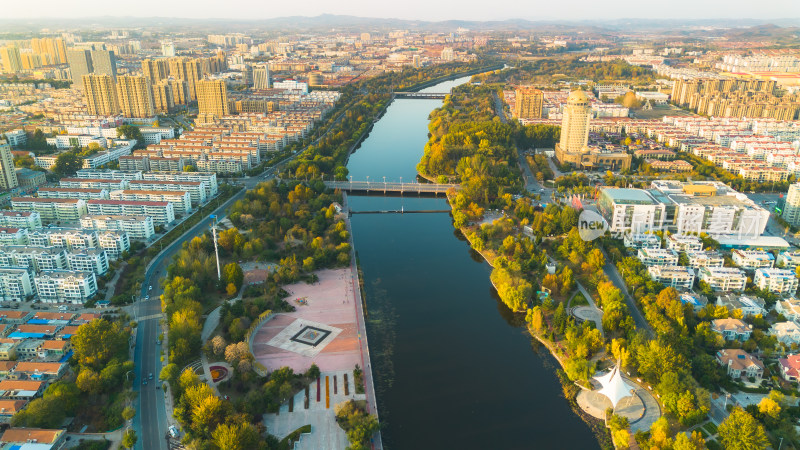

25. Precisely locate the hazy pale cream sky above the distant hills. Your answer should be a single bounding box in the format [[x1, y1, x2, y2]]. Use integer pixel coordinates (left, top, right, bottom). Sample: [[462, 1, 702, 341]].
[[6, 0, 800, 20]]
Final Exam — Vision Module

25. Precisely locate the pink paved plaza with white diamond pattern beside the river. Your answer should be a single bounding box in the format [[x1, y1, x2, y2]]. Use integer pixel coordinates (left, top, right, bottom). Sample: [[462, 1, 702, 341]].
[[252, 269, 362, 372]]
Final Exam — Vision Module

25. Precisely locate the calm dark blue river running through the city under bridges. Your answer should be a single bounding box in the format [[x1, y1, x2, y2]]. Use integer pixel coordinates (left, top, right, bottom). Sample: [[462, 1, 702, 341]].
[[348, 78, 599, 450]]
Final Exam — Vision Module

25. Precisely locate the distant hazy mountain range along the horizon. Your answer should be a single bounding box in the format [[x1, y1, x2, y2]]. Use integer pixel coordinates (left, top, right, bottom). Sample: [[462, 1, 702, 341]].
[[0, 14, 800, 34]]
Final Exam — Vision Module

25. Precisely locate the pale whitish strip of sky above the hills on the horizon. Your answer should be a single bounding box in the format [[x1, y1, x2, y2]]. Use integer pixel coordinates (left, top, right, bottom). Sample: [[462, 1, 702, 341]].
[[3, 0, 800, 22]]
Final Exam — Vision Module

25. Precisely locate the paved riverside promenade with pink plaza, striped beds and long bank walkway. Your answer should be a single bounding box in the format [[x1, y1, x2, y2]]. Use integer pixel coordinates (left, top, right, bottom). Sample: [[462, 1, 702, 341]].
[[250, 193, 383, 450]]
